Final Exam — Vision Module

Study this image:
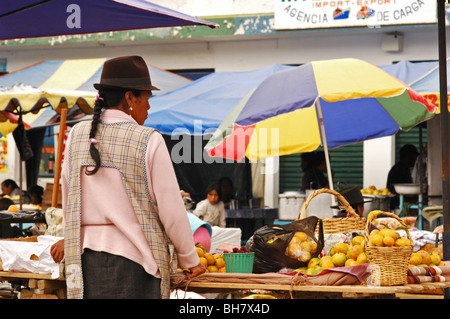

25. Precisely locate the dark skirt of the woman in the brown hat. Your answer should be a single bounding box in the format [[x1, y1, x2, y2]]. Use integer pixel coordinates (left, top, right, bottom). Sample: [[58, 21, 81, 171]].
[[81, 249, 161, 299]]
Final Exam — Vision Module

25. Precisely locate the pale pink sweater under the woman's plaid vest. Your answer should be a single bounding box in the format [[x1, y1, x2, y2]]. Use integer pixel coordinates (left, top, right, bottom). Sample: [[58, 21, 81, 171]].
[[61, 110, 199, 277]]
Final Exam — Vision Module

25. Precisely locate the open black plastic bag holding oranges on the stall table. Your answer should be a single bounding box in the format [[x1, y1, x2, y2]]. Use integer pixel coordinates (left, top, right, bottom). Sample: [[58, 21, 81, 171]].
[[246, 216, 324, 273]]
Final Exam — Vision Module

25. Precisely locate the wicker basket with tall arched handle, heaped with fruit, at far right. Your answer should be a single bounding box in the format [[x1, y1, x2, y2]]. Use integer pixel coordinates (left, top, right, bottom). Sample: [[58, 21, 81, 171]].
[[364, 211, 413, 286]]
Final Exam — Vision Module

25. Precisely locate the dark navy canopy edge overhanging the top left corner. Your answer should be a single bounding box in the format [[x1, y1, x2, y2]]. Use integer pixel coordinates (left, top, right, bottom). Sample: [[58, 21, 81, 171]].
[[0, 0, 218, 40]]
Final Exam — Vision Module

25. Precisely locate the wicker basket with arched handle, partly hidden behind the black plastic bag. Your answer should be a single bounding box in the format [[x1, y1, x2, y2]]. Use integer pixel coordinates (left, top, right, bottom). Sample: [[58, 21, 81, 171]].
[[297, 188, 366, 234]]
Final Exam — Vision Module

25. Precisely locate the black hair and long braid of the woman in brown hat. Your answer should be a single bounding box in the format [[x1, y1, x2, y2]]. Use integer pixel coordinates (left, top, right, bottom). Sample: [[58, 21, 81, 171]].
[[86, 89, 142, 175]]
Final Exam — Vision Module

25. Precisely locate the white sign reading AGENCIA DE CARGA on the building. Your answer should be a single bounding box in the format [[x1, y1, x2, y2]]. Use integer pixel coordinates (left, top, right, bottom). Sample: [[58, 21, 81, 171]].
[[275, 0, 437, 30]]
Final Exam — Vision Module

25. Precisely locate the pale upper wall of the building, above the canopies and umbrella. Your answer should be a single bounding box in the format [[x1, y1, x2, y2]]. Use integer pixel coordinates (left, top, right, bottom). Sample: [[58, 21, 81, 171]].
[[0, 28, 438, 71]]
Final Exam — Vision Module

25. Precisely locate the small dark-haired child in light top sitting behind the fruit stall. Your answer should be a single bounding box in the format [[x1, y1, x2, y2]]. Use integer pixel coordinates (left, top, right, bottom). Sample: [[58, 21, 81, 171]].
[[193, 184, 226, 227]]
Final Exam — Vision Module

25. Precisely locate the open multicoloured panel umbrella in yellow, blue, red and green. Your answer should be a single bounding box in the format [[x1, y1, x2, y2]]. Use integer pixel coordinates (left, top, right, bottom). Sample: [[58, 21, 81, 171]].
[[205, 58, 436, 186]]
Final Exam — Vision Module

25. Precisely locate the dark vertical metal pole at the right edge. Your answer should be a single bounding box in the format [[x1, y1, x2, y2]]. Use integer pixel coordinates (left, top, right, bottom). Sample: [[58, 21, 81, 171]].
[[438, 0, 450, 299]]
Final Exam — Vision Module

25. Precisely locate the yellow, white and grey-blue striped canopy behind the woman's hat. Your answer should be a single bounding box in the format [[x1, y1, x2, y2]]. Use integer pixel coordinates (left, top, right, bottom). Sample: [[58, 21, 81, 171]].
[[0, 58, 192, 135]]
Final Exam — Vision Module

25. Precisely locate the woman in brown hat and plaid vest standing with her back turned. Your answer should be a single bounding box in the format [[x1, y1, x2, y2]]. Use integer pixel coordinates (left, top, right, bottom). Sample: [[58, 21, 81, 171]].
[[52, 56, 205, 299]]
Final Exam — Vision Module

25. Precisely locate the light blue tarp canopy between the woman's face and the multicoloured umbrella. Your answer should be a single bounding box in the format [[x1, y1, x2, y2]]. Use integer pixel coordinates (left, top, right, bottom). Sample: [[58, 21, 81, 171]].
[[144, 64, 292, 135]]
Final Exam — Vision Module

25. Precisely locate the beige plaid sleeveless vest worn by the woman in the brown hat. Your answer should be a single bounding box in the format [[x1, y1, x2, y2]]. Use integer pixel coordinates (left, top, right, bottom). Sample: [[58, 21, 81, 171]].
[[64, 122, 171, 299]]
